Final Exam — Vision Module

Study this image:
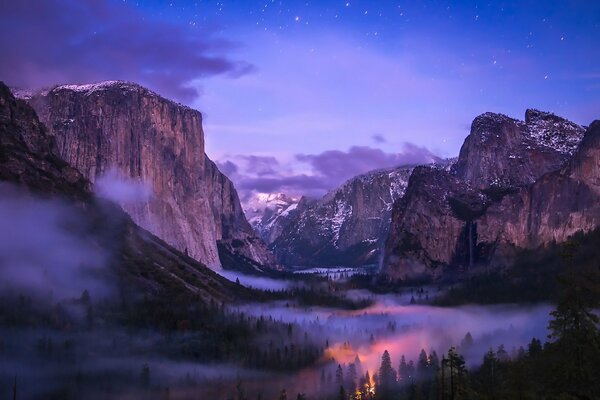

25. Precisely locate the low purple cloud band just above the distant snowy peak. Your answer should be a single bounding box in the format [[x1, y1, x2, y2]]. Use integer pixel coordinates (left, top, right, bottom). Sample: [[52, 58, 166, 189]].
[[217, 143, 439, 200]]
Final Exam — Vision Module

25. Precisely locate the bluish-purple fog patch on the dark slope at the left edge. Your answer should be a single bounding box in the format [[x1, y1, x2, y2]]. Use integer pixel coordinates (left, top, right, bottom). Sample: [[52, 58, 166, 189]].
[[0, 184, 109, 299]]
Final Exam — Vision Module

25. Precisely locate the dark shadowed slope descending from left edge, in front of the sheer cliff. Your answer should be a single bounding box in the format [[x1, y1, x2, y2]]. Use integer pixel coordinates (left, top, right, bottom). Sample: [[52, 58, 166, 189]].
[[0, 82, 248, 304]]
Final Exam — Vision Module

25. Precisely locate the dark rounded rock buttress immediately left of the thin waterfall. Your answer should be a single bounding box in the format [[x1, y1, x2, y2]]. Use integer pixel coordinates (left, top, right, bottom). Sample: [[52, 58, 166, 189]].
[[384, 166, 489, 279]]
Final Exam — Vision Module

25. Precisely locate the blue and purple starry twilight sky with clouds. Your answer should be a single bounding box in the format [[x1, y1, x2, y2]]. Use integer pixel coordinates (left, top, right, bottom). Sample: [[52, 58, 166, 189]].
[[0, 0, 600, 196]]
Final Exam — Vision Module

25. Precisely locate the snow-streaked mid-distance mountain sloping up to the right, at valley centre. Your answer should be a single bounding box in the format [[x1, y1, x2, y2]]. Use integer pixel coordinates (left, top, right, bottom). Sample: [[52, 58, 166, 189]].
[[271, 167, 413, 266]]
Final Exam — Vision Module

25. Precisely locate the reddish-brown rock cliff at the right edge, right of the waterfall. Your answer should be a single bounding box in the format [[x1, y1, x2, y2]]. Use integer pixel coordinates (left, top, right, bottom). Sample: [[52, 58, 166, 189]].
[[479, 121, 600, 252]]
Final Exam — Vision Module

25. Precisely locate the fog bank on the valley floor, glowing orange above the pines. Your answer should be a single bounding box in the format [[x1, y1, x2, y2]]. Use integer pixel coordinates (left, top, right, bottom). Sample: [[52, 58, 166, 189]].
[[232, 295, 551, 371]]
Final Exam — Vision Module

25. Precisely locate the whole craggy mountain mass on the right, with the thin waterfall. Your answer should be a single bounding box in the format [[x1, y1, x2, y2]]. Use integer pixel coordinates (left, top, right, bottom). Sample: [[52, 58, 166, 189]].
[[384, 110, 588, 279]]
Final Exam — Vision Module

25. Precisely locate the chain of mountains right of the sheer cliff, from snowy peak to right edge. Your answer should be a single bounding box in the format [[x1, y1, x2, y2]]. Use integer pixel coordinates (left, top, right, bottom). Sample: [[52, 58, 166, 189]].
[[246, 109, 600, 279]]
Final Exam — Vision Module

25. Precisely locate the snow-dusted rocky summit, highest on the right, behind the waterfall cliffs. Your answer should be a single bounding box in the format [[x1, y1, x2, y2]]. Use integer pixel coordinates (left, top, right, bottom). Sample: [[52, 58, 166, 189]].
[[453, 110, 584, 189]]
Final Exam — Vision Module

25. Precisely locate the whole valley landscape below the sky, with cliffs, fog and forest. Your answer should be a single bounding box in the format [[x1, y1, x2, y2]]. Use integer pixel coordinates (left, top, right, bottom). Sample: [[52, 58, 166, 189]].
[[0, 62, 600, 400]]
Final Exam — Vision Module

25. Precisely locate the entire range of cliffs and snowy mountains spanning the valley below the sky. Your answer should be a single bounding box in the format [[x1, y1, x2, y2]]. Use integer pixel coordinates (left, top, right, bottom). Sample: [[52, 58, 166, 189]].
[[3, 81, 600, 280]]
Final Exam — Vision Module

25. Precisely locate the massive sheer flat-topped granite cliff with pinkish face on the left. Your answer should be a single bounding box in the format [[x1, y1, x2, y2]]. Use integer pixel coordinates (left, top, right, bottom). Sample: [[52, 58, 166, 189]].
[[20, 81, 277, 270]]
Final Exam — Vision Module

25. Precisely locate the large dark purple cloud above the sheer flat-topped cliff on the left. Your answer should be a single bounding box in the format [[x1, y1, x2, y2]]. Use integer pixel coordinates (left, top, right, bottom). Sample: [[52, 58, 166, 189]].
[[0, 0, 253, 102]]
